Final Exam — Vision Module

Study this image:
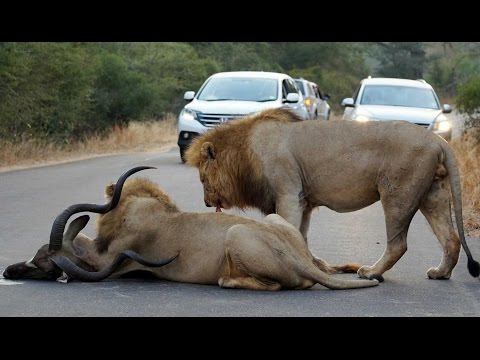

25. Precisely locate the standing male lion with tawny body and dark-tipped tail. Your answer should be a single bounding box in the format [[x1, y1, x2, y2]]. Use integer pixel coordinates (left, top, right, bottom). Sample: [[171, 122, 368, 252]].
[[185, 109, 480, 281]]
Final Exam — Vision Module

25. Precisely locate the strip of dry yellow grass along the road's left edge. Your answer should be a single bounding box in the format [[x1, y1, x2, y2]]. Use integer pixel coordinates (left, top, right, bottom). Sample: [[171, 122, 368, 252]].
[[0, 114, 177, 171]]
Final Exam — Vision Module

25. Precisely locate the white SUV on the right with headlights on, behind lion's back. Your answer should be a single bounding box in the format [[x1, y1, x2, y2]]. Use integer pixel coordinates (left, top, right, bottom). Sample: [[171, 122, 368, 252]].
[[342, 77, 452, 140]]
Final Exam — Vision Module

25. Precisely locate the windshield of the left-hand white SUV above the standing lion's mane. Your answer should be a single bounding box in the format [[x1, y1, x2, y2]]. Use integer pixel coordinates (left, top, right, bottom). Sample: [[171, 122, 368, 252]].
[[198, 77, 278, 102]]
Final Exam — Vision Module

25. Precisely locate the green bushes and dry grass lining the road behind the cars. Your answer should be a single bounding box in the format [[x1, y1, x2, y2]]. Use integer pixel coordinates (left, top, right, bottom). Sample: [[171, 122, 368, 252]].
[[0, 42, 480, 236]]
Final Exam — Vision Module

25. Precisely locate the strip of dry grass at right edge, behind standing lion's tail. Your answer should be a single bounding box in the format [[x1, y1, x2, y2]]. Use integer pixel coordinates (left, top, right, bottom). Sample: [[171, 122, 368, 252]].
[[451, 130, 480, 237]]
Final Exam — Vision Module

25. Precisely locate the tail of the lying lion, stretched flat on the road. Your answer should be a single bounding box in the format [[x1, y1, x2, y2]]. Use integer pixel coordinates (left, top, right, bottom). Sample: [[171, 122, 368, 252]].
[[298, 262, 379, 290]]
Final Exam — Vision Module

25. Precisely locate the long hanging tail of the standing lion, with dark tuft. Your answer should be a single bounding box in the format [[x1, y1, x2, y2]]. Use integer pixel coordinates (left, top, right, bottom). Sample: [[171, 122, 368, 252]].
[[442, 142, 480, 277]]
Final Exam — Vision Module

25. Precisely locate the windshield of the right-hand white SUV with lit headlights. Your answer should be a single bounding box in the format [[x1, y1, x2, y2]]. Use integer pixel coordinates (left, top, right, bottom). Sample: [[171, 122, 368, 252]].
[[360, 85, 439, 109]]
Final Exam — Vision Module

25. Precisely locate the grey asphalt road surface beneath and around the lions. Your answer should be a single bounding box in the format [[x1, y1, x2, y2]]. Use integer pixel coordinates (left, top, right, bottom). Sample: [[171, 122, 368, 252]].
[[0, 148, 480, 317]]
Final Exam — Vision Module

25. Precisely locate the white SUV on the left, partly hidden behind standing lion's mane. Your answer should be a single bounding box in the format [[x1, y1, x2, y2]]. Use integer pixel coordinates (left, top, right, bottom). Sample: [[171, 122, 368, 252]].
[[177, 71, 308, 161]]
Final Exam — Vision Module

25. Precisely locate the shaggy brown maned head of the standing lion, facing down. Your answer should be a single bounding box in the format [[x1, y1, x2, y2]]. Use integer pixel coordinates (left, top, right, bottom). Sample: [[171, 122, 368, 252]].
[[185, 109, 302, 214]]
